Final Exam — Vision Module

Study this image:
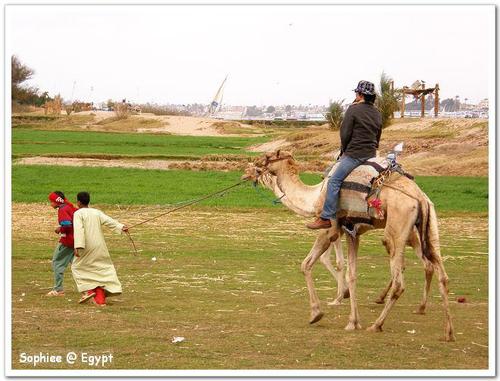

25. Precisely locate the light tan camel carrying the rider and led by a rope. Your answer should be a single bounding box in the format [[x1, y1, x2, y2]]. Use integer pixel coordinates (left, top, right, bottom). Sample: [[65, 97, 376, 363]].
[[248, 150, 455, 341]]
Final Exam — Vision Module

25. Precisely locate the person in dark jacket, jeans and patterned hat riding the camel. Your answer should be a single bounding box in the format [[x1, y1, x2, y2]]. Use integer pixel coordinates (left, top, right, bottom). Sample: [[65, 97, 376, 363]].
[[307, 81, 382, 229]]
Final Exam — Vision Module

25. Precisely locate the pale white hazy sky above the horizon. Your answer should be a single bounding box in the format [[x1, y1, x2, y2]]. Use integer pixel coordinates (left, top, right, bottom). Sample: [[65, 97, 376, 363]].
[[6, 5, 495, 105]]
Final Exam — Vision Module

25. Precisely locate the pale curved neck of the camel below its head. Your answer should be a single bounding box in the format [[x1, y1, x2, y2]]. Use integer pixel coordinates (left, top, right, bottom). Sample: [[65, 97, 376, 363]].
[[276, 167, 326, 215]]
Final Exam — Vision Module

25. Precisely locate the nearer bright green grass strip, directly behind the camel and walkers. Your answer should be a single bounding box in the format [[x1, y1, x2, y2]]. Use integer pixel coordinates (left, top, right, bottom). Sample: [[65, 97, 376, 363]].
[[12, 165, 488, 213]]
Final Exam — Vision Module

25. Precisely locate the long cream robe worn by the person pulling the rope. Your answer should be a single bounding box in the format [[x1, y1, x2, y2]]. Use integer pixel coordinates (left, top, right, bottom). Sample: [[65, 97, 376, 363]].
[[71, 208, 123, 294]]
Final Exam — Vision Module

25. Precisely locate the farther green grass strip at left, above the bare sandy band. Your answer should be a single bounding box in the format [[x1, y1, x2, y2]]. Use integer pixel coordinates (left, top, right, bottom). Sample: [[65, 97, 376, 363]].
[[12, 128, 269, 158]]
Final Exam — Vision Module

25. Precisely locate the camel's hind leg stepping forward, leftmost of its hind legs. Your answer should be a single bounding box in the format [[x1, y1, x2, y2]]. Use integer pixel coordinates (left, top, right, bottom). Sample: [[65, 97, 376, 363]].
[[368, 216, 413, 331]]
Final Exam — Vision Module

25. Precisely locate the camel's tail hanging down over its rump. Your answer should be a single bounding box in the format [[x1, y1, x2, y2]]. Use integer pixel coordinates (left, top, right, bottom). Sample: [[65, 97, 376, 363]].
[[418, 197, 439, 261]]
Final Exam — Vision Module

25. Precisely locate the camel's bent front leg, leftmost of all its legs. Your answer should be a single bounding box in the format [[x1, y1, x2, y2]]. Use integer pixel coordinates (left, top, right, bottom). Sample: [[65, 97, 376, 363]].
[[300, 231, 331, 324]]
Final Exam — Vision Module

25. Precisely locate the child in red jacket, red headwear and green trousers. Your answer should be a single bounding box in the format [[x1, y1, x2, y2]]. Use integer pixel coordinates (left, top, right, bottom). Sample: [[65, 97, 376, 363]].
[[47, 191, 76, 296]]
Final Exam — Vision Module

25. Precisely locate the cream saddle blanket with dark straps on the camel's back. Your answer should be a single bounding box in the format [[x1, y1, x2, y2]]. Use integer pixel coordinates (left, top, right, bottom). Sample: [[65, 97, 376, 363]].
[[328, 157, 389, 223]]
